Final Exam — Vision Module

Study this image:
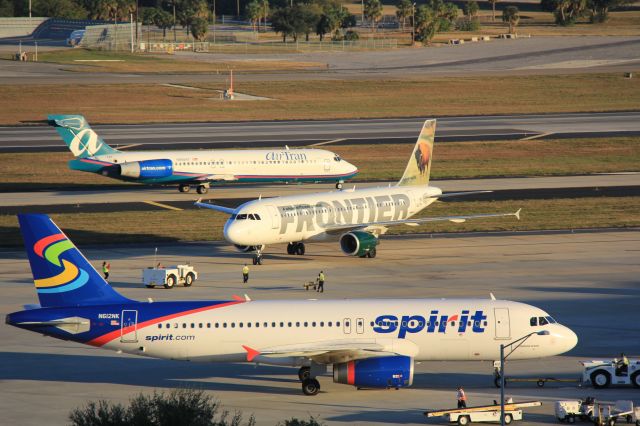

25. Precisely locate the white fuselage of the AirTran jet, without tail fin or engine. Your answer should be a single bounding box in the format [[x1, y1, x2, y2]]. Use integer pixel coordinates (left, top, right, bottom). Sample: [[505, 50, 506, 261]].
[[93, 149, 358, 181]]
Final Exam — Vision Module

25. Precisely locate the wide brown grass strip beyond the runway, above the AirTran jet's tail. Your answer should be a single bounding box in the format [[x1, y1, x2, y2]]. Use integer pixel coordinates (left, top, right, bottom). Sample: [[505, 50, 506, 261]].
[[0, 73, 640, 125]]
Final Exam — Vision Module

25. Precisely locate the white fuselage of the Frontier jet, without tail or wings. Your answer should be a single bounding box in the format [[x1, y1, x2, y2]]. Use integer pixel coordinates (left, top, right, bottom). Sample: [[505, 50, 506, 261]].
[[224, 181, 442, 246]]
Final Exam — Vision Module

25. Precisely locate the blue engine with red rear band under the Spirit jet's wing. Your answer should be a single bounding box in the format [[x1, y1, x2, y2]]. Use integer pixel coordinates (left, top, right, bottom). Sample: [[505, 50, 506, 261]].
[[333, 355, 413, 388]]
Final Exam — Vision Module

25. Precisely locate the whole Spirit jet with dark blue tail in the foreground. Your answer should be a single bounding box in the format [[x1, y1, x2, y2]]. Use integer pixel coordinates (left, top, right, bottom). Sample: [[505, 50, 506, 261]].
[[6, 214, 577, 395]]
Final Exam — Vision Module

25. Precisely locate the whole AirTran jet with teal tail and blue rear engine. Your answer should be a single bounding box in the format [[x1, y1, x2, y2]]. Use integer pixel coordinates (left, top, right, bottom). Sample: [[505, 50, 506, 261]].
[[49, 115, 358, 194]]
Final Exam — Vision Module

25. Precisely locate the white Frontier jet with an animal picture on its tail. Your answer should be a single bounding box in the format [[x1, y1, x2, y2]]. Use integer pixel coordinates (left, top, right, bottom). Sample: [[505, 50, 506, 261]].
[[196, 120, 520, 265]]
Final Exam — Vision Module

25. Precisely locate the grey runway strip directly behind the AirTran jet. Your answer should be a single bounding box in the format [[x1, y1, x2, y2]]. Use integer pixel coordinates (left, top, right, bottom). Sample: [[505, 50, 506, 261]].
[[0, 111, 640, 152]]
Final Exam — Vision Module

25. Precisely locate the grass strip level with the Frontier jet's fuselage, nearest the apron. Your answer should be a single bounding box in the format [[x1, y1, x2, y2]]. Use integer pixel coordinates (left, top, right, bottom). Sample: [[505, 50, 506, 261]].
[[0, 197, 640, 247]]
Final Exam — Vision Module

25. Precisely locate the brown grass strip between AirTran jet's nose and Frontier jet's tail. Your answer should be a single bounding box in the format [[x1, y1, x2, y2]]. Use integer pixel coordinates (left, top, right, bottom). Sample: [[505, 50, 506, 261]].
[[0, 137, 640, 190]]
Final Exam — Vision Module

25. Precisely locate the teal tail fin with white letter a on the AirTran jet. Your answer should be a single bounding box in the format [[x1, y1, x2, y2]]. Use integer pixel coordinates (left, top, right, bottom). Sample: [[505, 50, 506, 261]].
[[48, 115, 120, 158]]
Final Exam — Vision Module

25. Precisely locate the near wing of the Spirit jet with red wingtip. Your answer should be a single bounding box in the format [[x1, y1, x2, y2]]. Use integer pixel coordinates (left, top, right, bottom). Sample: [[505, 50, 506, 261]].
[[243, 339, 398, 364]]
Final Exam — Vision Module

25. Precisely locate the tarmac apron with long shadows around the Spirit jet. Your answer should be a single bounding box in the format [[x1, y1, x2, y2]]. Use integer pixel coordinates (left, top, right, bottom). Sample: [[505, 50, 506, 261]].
[[0, 231, 640, 426]]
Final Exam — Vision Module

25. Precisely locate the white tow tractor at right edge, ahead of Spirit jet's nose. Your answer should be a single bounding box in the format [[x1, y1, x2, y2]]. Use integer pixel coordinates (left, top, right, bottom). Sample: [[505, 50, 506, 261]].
[[580, 359, 640, 389]]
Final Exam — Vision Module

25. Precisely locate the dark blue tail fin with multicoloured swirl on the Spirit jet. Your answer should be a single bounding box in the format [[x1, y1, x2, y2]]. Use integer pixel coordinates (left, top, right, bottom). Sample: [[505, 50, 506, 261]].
[[18, 214, 133, 308]]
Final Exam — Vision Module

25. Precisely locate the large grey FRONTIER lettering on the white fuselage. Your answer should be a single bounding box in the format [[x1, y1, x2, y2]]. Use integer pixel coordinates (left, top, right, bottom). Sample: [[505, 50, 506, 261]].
[[277, 193, 409, 234]]
